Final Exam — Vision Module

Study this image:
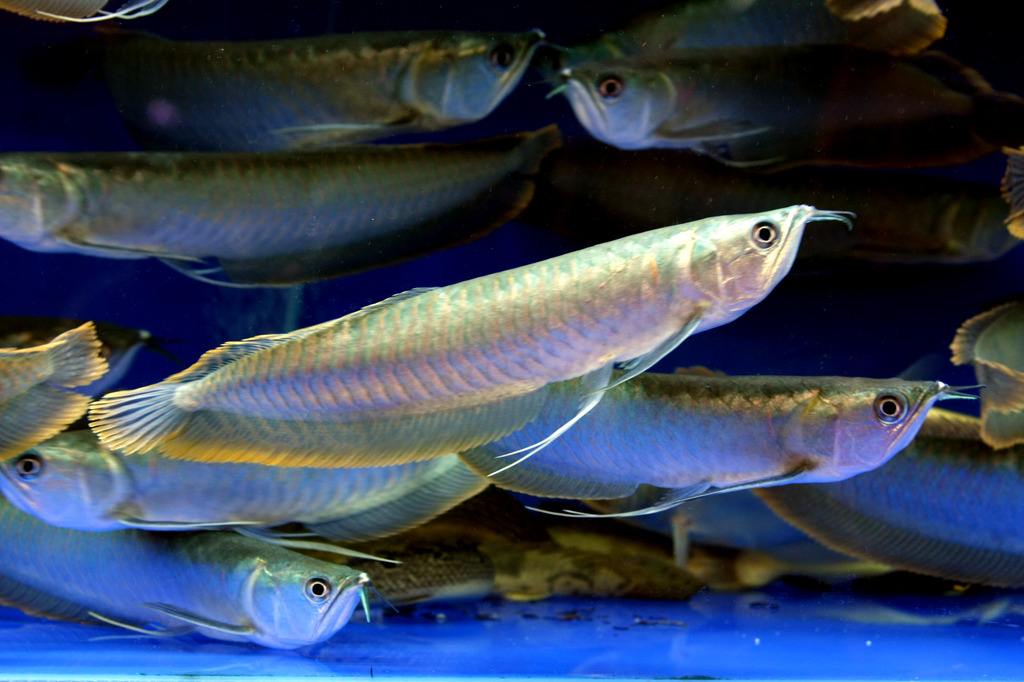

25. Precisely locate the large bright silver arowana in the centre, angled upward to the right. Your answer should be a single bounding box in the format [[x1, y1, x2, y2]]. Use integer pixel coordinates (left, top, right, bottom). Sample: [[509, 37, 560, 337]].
[[90, 206, 831, 467]]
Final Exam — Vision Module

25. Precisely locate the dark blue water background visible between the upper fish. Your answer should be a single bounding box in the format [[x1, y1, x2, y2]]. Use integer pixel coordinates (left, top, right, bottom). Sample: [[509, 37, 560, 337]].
[[0, 0, 1024, 393]]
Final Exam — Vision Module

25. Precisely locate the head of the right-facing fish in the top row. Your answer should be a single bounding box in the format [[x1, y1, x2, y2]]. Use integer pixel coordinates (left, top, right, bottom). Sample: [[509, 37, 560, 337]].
[[401, 30, 544, 126]]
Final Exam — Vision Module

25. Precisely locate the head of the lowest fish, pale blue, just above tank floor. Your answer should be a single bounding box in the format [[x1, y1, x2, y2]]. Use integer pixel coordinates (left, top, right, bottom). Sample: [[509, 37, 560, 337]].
[[243, 551, 370, 649]]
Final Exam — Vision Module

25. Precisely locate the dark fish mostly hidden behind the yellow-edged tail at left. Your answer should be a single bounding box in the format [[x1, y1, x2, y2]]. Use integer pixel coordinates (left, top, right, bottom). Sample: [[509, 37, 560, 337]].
[[0, 316, 159, 395]]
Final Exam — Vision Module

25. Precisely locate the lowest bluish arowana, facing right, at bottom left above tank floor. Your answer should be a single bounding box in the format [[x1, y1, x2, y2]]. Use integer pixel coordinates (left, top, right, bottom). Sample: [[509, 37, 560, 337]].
[[0, 493, 369, 649]]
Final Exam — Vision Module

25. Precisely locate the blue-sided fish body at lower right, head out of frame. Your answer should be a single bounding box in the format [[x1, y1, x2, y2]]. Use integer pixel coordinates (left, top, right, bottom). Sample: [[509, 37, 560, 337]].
[[758, 411, 1024, 587]]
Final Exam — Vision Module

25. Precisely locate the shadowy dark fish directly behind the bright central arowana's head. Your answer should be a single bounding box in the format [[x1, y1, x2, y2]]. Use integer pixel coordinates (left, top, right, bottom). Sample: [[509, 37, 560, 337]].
[[520, 145, 1024, 264]]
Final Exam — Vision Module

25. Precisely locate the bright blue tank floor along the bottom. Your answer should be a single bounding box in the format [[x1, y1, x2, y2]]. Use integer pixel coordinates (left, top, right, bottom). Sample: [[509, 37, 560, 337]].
[[0, 590, 1024, 680]]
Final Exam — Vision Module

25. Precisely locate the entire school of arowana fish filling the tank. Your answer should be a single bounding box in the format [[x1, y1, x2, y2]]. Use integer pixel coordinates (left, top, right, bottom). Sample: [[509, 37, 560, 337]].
[[0, 0, 1024, 649]]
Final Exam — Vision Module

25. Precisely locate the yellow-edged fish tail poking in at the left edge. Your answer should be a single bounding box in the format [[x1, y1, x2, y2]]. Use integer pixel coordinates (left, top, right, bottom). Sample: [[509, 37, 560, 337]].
[[0, 323, 106, 460]]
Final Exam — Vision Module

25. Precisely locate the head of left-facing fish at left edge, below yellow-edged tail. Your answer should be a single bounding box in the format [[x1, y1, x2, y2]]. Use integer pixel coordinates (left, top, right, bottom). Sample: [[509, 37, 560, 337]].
[[0, 431, 131, 530]]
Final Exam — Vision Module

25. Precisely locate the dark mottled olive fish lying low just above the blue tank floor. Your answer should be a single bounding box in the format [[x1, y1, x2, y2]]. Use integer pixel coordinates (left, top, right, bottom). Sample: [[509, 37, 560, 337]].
[[323, 489, 700, 604]]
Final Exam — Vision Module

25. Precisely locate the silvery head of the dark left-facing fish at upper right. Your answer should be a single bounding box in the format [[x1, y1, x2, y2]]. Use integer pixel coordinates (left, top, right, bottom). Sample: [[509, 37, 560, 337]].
[[558, 62, 676, 150]]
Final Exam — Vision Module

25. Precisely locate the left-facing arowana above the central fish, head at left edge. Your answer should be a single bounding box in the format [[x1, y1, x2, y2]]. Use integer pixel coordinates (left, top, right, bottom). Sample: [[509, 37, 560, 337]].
[[0, 126, 560, 285]]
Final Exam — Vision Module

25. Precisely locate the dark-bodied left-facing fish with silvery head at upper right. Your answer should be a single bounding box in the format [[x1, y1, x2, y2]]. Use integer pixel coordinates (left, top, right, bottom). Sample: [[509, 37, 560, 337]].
[[563, 45, 1024, 167]]
